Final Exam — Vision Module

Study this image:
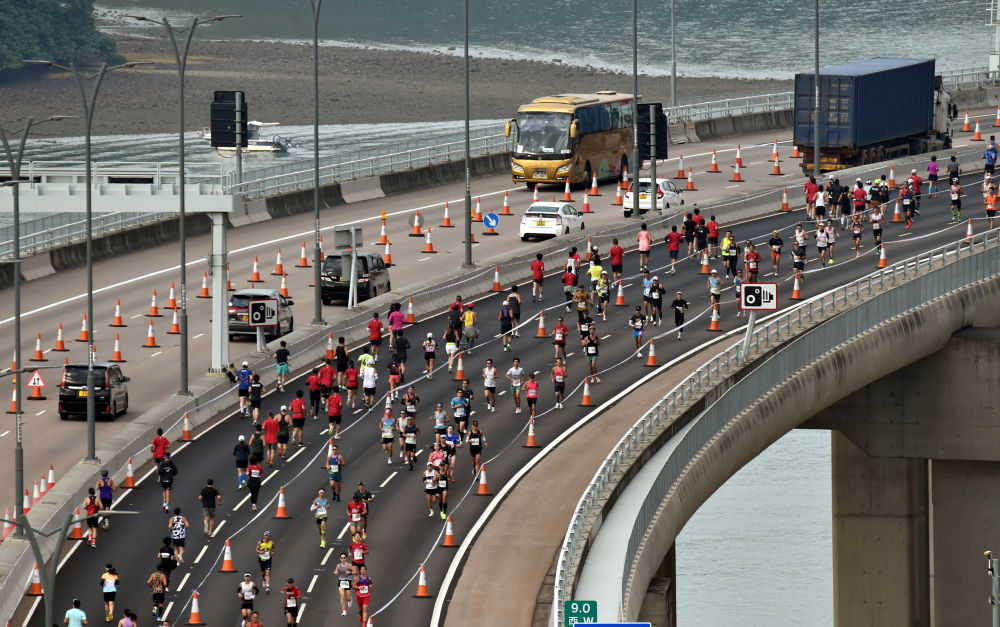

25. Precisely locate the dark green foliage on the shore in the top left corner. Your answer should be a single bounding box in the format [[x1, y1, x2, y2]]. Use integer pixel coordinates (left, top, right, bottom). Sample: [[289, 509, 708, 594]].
[[0, 0, 121, 70]]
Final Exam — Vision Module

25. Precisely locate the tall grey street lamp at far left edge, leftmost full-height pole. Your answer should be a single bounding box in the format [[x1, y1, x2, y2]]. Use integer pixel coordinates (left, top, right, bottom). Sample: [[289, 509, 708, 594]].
[[0, 115, 69, 534]]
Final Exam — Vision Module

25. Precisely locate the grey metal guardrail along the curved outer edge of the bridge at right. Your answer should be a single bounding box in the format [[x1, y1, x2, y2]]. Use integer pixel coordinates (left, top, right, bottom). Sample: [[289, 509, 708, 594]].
[[552, 224, 1000, 627]]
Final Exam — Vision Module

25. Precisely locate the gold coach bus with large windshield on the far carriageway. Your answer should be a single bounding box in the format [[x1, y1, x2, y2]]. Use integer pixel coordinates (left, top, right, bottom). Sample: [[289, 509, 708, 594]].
[[505, 91, 632, 189]]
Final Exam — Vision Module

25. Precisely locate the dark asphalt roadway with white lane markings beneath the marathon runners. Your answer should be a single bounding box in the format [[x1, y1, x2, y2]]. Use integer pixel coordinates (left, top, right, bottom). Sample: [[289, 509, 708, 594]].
[[26, 169, 986, 627]]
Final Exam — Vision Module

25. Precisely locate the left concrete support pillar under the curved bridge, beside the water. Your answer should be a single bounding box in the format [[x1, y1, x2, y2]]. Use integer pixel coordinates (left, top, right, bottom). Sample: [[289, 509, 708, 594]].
[[831, 431, 928, 627]]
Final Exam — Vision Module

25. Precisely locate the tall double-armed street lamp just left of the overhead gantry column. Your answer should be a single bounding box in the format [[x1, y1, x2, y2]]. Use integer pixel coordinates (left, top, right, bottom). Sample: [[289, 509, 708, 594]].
[[127, 15, 240, 392]]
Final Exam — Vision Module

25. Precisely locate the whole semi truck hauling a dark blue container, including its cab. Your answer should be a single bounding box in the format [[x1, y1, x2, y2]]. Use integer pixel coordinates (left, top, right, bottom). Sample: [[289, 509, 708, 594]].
[[793, 57, 951, 173]]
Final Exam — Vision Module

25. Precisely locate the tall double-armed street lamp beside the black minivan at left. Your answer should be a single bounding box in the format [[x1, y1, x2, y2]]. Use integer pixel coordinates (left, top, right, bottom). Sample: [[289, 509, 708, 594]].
[[19, 59, 149, 461]]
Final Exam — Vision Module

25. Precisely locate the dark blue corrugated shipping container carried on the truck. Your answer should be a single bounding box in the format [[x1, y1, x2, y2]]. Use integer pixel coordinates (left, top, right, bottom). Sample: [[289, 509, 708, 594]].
[[794, 57, 934, 148]]
